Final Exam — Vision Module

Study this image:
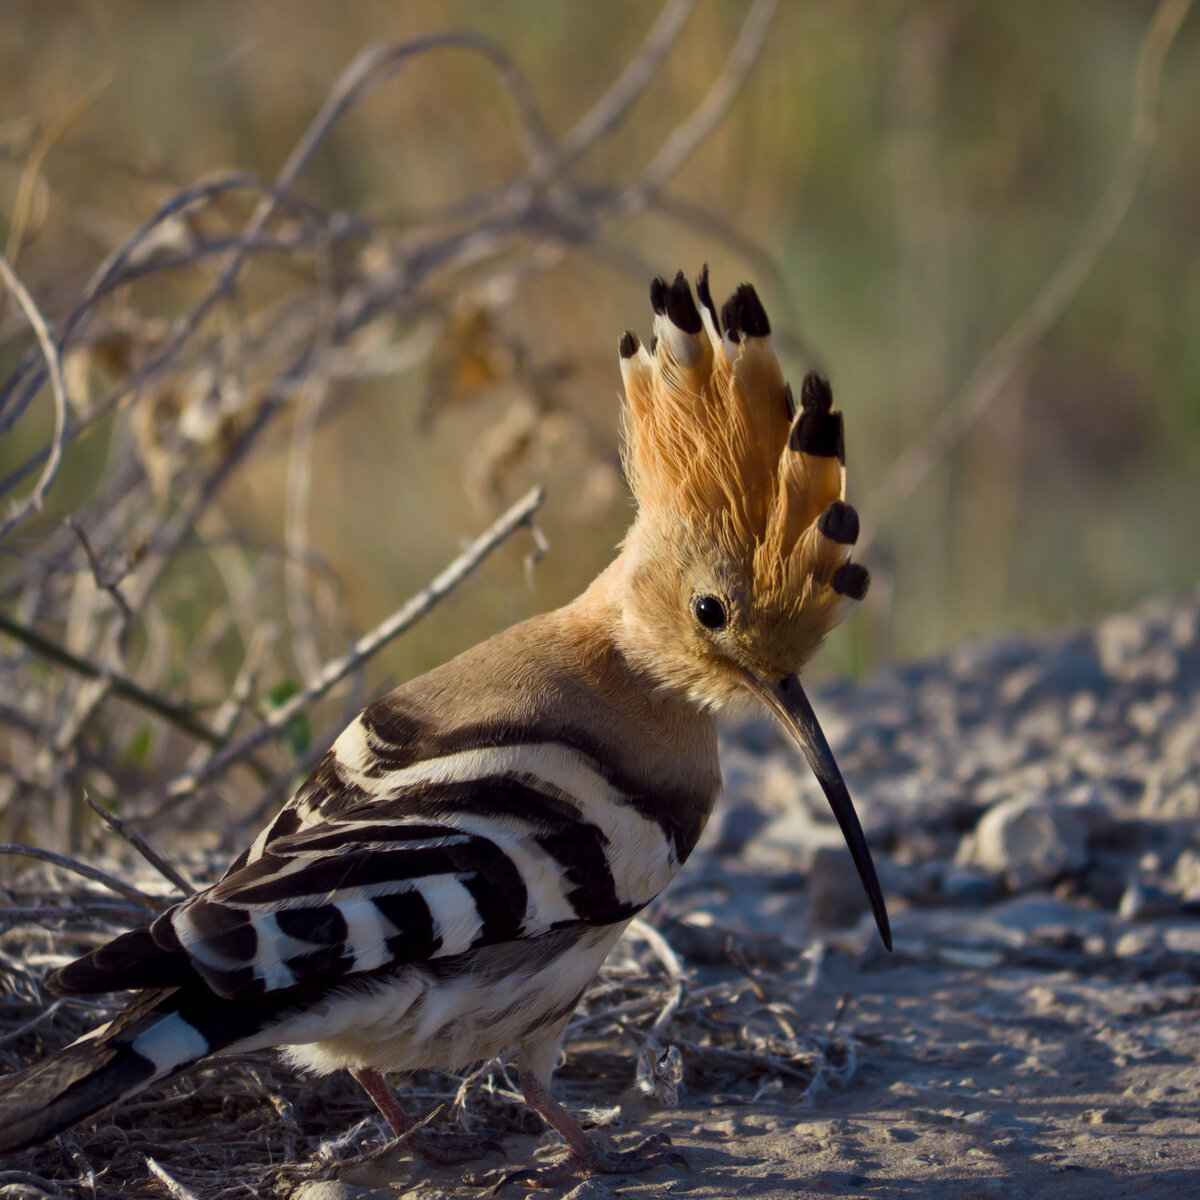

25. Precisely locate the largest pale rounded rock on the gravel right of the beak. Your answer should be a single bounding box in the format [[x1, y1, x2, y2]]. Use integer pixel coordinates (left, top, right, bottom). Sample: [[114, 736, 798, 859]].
[[960, 796, 1087, 890]]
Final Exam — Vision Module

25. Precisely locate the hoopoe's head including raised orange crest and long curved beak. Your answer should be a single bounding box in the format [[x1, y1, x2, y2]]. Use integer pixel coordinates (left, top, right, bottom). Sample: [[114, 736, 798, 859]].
[[619, 269, 890, 944]]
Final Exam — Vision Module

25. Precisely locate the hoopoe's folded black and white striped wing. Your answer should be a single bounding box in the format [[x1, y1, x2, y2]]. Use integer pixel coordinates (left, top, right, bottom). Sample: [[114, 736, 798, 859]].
[[51, 709, 678, 1000]]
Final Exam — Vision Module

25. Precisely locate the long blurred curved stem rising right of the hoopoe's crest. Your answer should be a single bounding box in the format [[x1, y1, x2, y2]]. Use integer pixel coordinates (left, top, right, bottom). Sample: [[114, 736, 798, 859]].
[[858, 0, 1192, 553]]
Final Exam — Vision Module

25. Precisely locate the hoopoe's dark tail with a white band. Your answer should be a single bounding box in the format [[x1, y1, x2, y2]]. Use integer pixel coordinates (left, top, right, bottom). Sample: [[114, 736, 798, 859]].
[[0, 990, 233, 1154]]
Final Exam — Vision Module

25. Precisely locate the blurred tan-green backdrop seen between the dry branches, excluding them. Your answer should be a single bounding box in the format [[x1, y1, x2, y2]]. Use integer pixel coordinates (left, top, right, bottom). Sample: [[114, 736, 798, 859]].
[[0, 0, 1200, 705]]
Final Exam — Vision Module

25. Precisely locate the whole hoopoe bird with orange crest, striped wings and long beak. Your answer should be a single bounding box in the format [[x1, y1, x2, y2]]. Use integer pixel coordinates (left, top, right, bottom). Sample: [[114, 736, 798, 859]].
[[0, 268, 890, 1186]]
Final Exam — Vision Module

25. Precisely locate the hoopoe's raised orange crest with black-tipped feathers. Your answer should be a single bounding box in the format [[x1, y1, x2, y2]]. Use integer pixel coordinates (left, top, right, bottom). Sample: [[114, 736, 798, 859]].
[[619, 268, 869, 686]]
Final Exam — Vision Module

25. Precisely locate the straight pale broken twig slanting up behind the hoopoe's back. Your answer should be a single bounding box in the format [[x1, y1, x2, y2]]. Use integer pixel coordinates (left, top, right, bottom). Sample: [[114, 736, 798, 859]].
[[167, 487, 546, 798]]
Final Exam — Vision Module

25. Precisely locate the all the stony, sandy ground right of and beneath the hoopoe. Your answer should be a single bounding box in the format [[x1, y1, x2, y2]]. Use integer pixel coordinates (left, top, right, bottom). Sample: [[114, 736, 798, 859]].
[[0, 599, 1200, 1200]]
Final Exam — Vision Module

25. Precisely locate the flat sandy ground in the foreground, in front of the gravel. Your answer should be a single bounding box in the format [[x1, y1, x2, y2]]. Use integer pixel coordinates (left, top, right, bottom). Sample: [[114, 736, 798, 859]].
[[336, 955, 1200, 1200]]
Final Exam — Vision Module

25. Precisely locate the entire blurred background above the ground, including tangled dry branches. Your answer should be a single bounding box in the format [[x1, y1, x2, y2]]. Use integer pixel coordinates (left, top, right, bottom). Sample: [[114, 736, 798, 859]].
[[0, 0, 1200, 835]]
